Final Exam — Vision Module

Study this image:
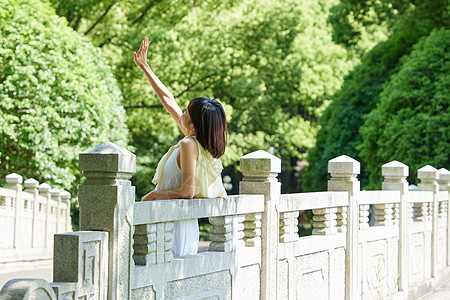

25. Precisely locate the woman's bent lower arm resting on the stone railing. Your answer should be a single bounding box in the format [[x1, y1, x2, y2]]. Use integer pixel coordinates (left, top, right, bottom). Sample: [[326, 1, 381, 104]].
[[142, 138, 198, 201]]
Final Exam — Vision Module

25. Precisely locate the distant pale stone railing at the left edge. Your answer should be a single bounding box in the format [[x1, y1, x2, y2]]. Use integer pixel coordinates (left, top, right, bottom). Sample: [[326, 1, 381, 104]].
[[0, 173, 72, 269]]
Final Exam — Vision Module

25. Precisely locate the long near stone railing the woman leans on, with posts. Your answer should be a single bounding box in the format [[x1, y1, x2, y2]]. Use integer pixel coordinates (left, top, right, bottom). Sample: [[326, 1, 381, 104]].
[[0, 143, 450, 299]]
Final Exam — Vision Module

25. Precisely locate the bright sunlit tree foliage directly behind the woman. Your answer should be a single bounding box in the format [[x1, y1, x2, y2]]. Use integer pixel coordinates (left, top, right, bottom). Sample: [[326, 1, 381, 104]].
[[45, 0, 357, 193]]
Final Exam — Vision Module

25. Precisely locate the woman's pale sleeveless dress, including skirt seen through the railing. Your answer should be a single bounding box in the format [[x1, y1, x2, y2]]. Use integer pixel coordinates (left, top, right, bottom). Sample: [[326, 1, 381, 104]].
[[152, 137, 227, 257]]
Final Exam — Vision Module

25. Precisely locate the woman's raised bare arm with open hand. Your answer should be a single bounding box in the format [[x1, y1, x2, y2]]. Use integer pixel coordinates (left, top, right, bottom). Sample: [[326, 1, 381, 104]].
[[133, 37, 187, 135]]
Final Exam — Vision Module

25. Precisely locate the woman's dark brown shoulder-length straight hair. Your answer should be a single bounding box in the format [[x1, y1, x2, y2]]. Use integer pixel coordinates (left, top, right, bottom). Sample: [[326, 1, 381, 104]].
[[188, 97, 227, 158]]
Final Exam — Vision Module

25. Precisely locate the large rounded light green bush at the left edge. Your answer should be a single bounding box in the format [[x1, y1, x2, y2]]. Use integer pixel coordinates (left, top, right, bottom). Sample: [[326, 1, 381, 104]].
[[0, 0, 127, 190]]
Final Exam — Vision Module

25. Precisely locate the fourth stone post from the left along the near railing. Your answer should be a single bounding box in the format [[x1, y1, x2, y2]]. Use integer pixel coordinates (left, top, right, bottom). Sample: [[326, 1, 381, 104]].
[[381, 160, 409, 293]]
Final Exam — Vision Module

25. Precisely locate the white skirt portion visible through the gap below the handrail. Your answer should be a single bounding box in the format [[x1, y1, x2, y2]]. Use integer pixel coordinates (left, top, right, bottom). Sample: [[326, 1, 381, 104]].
[[172, 219, 200, 257]]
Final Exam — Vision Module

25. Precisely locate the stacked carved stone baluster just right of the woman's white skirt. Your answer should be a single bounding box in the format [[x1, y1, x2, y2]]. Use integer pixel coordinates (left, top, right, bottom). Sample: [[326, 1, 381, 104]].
[[209, 216, 233, 252]]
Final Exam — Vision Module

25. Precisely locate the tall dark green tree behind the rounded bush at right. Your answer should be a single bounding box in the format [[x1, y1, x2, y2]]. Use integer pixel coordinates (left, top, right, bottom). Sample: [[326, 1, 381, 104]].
[[303, 0, 449, 190]]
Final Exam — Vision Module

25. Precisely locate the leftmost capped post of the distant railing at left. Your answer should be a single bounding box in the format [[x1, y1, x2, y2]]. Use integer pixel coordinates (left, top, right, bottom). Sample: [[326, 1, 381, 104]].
[[6, 173, 24, 248]]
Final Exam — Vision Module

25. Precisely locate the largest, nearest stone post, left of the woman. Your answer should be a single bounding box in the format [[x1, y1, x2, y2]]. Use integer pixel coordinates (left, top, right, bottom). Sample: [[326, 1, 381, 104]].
[[79, 142, 136, 299]]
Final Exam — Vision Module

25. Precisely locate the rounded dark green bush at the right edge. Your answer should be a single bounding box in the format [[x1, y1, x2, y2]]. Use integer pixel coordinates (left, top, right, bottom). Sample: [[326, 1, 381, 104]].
[[359, 29, 450, 187]]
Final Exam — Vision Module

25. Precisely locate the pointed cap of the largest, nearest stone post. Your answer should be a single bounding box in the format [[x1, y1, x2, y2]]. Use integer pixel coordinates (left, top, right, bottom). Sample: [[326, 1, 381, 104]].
[[79, 142, 136, 173]]
